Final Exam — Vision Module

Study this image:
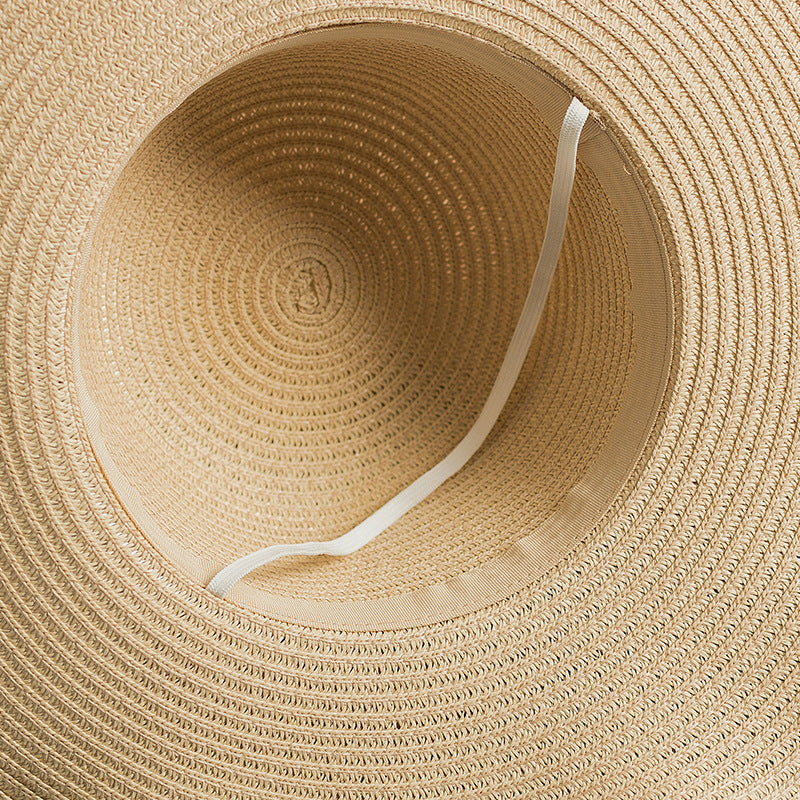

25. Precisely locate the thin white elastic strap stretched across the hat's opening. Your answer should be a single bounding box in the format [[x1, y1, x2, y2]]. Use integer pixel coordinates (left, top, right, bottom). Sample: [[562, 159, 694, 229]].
[[207, 98, 589, 597]]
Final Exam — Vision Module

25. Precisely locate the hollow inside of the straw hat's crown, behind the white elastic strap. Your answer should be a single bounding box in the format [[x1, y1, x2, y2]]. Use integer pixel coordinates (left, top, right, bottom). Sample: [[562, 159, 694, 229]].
[[77, 25, 671, 624]]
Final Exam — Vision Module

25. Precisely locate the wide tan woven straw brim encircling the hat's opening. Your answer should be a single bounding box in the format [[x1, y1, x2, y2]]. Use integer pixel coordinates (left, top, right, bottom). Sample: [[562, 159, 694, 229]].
[[0, 0, 800, 800]]
